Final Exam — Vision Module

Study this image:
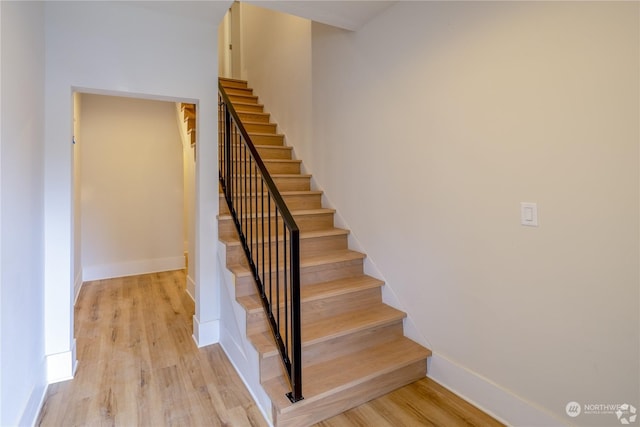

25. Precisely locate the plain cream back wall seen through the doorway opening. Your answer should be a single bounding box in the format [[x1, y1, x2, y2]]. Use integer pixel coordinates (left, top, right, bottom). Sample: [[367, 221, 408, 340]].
[[76, 94, 184, 280]]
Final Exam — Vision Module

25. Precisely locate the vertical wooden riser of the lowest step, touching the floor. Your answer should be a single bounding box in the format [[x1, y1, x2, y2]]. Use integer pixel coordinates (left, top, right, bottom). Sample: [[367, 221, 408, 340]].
[[273, 360, 427, 427]]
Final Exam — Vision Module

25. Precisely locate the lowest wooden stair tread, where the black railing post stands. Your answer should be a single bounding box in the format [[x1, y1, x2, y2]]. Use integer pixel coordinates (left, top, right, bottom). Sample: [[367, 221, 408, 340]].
[[264, 337, 431, 413]]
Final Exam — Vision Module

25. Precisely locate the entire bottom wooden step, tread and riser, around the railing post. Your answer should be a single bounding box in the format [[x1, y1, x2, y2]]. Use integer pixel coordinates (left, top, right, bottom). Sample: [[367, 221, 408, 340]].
[[263, 337, 431, 427]]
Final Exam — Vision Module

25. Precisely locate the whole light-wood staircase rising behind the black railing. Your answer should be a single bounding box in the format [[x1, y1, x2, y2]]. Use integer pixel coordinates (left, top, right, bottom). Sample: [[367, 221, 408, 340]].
[[218, 79, 431, 427]]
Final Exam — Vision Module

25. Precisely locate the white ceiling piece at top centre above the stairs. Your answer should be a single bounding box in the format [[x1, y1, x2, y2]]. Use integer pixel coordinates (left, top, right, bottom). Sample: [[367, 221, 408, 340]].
[[245, 0, 396, 31]]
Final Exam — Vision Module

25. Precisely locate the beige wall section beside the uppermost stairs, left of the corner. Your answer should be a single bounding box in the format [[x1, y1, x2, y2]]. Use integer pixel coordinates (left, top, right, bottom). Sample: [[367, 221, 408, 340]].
[[239, 3, 312, 159]]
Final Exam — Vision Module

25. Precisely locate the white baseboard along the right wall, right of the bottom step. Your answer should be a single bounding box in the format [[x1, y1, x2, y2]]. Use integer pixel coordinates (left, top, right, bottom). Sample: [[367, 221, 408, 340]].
[[427, 353, 565, 427]]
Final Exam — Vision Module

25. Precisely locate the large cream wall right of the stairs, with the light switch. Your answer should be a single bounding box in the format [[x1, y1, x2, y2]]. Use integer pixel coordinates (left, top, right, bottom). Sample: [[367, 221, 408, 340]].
[[308, 2, 640, 425]]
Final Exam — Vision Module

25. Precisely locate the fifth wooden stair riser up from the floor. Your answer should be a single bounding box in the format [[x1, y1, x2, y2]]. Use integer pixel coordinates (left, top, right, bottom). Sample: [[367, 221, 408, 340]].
[[227, 234, 348, 266]]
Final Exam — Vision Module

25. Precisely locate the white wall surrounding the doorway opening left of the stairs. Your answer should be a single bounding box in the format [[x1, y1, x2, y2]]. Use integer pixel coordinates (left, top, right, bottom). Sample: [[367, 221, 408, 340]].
[[44, 1, 230, 381]]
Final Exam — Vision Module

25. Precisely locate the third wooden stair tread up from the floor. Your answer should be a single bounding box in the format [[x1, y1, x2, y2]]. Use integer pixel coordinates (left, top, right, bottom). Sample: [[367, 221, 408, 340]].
[[237, 274, 384, 313]]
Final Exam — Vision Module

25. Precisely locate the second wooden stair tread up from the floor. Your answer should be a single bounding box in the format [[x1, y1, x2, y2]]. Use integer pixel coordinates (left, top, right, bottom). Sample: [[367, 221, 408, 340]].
[[249, 302, 407, 358]]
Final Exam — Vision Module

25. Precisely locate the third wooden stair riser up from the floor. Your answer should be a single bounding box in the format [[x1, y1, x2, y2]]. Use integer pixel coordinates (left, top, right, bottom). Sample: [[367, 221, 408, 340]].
[[247, 288, 382, 340]]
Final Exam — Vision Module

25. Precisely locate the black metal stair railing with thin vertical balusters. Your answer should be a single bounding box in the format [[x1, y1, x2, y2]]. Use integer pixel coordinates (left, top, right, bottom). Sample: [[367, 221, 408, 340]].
[[218, 82, 303, 402]]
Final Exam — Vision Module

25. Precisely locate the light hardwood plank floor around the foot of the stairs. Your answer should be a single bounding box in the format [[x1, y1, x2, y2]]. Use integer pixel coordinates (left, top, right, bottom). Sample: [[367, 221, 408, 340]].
[[38, 270, 501, 427]]
